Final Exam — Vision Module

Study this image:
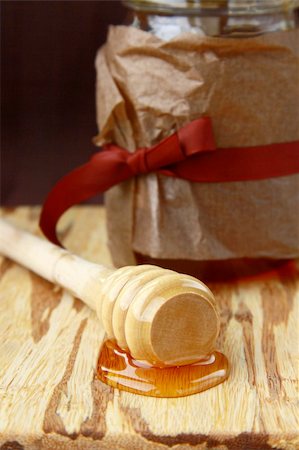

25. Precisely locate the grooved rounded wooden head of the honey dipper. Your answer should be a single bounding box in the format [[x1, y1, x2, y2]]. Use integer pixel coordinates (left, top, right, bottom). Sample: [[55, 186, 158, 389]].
[[99, 265, 219, 367]]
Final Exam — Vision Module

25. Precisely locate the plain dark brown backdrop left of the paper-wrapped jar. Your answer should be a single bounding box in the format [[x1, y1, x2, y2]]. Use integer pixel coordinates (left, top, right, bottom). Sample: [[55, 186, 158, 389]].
[[1, 0, 127, 206]]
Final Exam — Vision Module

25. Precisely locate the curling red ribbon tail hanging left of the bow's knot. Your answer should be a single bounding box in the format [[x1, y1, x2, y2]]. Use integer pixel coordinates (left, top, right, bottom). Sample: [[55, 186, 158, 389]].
[[39, 152, 131, 246]]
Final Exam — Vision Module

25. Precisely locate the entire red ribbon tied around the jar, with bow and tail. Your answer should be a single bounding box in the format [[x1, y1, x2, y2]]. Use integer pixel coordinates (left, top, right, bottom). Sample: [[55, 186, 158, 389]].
[[40, 117, 299, 245]]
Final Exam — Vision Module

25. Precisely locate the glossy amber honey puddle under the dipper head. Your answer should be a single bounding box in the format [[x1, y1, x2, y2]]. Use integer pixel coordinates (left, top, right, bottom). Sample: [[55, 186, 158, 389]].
[[97, 340, 229, 397]]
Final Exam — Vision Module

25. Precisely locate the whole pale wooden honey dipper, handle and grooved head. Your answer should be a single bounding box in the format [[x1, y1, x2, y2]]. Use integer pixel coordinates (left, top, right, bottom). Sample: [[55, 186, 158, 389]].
[[0, 219, 219, 367]]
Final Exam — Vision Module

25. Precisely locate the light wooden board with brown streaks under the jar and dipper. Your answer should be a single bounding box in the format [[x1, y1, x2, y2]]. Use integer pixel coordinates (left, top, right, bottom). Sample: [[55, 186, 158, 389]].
[[0, 207, 299, 450]]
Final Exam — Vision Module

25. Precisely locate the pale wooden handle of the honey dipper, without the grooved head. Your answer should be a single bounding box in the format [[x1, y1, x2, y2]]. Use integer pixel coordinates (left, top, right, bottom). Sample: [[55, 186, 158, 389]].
[[0, 219, 112, 309]]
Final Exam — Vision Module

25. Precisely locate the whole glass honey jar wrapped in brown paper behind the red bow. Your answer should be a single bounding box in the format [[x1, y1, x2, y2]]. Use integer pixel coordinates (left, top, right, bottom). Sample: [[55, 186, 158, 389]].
[[95, 0, 299, 280]]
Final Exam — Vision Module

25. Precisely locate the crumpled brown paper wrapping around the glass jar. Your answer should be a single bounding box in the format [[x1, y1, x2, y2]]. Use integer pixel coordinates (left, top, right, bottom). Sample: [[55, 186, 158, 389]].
[[96, 26, 299, 266]]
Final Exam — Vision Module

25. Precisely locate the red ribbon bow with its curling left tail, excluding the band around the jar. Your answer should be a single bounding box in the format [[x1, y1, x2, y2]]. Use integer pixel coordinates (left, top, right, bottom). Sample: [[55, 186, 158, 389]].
[[40, 117, 216, 245]]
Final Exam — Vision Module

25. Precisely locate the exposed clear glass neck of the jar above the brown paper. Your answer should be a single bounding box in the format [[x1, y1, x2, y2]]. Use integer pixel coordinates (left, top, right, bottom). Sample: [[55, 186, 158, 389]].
[[124, 0, 295, 40]]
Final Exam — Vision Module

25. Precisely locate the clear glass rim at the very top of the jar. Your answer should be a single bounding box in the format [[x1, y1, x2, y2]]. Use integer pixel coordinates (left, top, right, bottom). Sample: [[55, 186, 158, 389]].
[[122, 0, 299, 16]]
